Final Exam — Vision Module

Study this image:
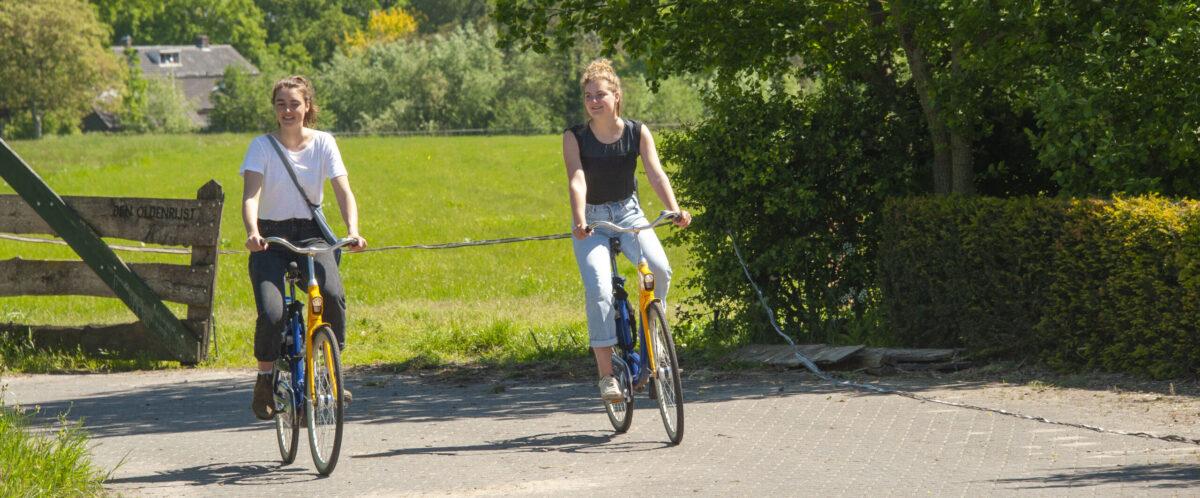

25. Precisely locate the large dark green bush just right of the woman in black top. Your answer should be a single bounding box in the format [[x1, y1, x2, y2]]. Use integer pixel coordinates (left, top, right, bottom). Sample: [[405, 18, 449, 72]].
[[660, 84, 926, 342]]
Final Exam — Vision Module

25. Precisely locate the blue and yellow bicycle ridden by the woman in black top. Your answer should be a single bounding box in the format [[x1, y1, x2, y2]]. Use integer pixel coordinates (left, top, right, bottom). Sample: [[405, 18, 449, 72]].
[[588, 211, 683, 444]]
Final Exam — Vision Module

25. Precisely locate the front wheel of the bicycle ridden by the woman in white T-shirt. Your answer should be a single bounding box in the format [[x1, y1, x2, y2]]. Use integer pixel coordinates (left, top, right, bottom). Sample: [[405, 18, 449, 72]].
[[305, 326, 346, 475]]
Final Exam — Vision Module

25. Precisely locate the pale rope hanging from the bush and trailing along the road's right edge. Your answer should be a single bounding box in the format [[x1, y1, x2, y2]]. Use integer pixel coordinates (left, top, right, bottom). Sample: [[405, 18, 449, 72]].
[[725, 230, 1200, 445]]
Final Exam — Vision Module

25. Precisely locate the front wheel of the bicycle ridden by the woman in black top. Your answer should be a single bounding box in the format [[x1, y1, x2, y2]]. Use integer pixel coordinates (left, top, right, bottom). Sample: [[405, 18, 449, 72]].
[[646, 302, 683, 444]]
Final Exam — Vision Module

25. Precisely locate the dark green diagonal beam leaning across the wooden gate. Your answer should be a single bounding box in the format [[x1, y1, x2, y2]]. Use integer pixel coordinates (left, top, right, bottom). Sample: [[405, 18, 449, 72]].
[[0, 139, 199, 361]]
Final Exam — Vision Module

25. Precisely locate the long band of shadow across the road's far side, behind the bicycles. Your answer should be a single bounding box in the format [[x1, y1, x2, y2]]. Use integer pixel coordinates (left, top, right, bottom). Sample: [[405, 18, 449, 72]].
[[4, 373, 847, 439]]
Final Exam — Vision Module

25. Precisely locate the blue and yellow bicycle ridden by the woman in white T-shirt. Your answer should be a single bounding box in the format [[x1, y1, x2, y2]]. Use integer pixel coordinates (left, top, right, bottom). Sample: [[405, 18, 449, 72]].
[[266, 236, 354, 475]]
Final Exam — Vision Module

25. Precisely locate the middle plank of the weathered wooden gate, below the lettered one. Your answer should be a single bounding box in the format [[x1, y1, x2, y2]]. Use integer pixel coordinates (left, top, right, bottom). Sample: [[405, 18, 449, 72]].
[[0, 258, 216, 308]]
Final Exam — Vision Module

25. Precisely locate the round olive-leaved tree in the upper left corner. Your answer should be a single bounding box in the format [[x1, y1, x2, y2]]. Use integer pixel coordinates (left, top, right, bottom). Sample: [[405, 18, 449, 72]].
[[0, 0, 120, 138]]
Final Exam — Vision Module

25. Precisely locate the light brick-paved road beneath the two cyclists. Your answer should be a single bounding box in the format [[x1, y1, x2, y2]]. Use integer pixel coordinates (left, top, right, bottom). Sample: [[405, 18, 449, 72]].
[[0, 370, 1200, 497]]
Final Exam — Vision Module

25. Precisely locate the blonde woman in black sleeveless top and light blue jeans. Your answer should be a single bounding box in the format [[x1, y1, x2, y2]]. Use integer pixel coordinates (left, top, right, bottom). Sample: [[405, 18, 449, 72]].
[[563, 59, 691, 401]]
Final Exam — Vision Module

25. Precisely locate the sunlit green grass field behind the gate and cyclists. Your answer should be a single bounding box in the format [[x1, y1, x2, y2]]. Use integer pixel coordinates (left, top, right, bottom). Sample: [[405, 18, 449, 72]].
[[0, 134, 692, 371]]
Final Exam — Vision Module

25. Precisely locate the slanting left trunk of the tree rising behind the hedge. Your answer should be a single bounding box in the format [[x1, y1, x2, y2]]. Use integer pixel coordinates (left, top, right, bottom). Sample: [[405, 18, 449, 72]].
[[892, 0, 954, 194]]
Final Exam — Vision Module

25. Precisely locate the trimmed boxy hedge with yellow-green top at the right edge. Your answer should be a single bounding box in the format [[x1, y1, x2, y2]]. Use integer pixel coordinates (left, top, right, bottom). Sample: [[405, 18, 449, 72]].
[[878, 197, 1200, 378]]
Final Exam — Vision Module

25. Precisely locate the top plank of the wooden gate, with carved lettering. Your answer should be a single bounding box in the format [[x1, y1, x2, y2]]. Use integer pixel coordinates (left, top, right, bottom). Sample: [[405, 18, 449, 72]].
[[0, 193, 223, 246]]
